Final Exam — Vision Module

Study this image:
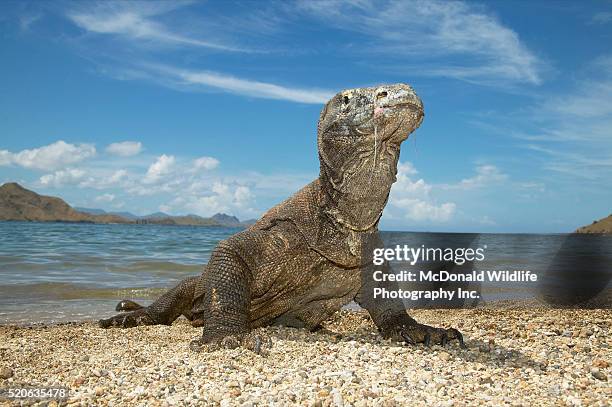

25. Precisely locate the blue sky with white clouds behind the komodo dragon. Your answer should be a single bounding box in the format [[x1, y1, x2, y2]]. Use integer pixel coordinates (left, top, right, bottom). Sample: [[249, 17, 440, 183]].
[[0, 0, 612, 232]]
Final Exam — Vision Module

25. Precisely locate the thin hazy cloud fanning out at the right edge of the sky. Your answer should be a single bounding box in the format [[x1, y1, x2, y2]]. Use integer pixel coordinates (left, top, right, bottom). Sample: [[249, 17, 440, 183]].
[[489, 55, 612, 185]]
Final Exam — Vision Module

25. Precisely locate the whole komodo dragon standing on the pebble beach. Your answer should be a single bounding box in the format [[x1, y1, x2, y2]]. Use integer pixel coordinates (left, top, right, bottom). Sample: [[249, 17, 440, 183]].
[[99, 84, 463, 352]]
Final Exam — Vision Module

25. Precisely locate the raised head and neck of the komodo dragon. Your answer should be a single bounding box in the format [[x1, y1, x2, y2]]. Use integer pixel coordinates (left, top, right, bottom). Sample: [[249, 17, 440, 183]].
[[318, 83, 424, 231]]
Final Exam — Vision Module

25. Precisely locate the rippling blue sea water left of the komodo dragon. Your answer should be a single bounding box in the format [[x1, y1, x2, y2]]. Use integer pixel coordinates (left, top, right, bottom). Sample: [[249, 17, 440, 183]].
[[0, 222, 241, 323]]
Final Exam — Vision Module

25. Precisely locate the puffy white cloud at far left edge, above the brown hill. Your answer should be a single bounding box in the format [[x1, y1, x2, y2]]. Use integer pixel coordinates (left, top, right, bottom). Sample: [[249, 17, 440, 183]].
[[0, 140, 96, 171]]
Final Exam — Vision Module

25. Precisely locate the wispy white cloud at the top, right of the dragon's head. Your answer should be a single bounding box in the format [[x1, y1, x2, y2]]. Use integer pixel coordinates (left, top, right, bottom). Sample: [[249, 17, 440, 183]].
[[298, 0, 542, 84]]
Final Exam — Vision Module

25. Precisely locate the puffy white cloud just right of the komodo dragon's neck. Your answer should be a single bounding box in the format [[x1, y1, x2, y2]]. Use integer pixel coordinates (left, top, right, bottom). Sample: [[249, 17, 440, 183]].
[[389, 162, 456, 222]]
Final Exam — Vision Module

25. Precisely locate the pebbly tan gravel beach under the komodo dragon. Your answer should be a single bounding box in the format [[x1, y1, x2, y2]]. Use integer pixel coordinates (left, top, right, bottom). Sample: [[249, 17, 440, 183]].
[[0, 308, 612, 406]]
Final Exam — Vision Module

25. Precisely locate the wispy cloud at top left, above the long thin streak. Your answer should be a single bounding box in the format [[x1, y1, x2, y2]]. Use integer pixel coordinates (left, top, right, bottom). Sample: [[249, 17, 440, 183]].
[[68, 2, 250, 52]]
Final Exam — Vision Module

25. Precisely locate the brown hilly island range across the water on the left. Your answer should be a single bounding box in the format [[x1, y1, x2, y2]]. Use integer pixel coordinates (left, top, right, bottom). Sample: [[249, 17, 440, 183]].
[[0, 182, 254, 227]]
